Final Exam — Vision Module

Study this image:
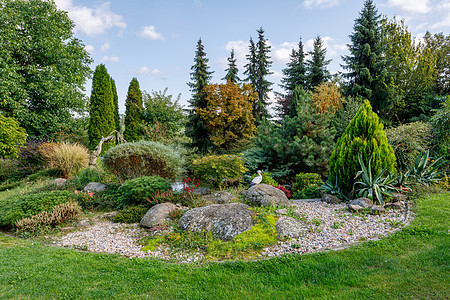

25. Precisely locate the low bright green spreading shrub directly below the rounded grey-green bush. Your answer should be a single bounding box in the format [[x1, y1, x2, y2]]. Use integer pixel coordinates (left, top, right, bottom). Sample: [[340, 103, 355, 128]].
[[119, 176, 172, 207]]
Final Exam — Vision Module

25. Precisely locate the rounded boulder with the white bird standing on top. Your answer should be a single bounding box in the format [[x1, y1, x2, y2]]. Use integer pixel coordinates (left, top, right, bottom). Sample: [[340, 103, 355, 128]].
[[244, 184, 291, 206]]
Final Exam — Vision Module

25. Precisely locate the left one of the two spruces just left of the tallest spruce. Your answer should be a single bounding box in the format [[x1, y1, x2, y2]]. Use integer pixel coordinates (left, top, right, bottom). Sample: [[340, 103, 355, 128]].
[[280, 38, 306, 94]]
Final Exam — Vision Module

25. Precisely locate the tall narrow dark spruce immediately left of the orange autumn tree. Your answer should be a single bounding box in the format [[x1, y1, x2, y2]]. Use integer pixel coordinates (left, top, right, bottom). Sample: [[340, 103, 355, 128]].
[[186, 39, 213, 153]]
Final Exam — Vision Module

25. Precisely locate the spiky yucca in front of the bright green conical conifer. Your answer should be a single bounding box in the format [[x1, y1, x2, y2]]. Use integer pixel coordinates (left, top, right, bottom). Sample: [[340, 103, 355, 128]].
[[354, 154, 397, 205]]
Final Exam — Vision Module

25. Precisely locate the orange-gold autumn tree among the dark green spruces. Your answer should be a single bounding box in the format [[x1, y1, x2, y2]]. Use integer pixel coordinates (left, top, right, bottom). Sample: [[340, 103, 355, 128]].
[[196, 81, 257, 151]]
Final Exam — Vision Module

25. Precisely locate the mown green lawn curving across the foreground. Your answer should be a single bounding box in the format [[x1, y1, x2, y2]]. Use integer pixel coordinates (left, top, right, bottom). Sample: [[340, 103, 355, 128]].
[[0, 192, 450, 299]]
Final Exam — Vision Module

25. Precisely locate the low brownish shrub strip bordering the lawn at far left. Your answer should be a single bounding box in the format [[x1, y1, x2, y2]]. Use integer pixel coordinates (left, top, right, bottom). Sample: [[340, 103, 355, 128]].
[[15, 201, 81, 232]]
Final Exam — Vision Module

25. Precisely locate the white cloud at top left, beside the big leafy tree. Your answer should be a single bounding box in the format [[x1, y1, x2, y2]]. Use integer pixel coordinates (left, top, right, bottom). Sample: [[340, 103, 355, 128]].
[[55, 0, 127, 36]]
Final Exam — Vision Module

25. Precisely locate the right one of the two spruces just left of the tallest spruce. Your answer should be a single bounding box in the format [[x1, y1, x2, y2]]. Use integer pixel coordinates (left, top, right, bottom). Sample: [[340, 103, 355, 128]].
[[306, 36, 331, 90]]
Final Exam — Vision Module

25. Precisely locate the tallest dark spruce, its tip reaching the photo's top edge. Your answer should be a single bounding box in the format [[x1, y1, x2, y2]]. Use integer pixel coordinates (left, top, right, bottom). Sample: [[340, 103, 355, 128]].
[[342, 0, 392, 113]]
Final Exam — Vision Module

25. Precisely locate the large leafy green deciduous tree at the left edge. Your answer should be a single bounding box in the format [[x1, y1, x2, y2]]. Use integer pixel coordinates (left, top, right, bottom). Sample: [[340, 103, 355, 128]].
[[0, 0, 92, 139]]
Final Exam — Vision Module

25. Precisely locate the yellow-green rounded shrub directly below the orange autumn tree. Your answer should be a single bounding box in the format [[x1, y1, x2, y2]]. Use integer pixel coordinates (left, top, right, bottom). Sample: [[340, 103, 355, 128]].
[[191, 154, 247, 187]]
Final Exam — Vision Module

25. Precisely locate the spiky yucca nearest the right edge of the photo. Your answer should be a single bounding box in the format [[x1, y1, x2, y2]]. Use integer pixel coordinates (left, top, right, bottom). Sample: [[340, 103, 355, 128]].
[[409, 150, 444, 186]]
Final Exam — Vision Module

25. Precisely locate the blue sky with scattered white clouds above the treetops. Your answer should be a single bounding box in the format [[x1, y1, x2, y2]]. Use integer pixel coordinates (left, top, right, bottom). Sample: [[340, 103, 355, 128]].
[[55, 0, 450, 113]]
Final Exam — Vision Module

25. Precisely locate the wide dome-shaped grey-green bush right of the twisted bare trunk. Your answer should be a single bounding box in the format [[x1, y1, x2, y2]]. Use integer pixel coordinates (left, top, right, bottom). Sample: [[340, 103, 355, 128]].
[[103, 141, 183, 182]]
